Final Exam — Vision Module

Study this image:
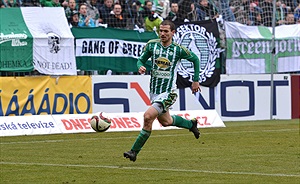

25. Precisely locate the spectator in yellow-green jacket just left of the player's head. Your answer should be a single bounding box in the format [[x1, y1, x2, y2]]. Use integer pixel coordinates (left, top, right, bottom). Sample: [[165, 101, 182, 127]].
[[145, 5, 163, 34]]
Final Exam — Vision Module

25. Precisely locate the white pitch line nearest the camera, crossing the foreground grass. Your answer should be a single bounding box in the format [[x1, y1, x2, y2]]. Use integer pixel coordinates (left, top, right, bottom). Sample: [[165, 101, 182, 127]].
[[0, 162, 300, 177]]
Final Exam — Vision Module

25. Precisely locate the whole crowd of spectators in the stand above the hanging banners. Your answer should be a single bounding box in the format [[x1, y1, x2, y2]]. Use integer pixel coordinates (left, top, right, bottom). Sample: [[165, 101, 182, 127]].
[[0, 0, 300, 31]]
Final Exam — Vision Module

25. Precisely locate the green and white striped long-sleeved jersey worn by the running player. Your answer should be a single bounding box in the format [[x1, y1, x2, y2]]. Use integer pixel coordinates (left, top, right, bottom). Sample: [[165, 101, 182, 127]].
[[137, 39, 200, 94]]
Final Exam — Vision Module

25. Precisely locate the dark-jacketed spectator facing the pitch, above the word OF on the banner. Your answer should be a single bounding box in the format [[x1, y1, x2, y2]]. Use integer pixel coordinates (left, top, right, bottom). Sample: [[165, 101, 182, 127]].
[[107, 4, 126, 28]]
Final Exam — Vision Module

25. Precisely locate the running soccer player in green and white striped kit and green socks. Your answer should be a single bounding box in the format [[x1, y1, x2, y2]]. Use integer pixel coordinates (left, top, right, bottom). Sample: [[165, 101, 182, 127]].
[[123, 20, 201, 162]]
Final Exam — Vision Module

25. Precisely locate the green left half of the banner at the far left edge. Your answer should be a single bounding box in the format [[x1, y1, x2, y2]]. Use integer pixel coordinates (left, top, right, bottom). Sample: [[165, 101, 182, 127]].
[[0, 8, 34, 72]]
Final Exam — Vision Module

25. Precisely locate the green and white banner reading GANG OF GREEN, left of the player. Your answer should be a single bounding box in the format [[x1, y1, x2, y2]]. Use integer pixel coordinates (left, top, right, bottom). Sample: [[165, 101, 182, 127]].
[[71, 27, 157, 72]]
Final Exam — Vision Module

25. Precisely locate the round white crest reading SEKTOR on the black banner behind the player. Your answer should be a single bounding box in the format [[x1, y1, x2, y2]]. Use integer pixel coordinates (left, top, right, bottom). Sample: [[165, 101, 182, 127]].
[[173, 24, 222, 83]]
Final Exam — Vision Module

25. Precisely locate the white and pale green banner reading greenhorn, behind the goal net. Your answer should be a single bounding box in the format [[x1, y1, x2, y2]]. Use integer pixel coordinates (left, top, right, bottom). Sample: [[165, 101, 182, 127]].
[[225, 22, 300, 74]]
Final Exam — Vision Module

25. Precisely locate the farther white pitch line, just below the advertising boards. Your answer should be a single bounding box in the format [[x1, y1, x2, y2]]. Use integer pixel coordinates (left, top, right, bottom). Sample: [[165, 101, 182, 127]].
[[0, 129, 298, 145]]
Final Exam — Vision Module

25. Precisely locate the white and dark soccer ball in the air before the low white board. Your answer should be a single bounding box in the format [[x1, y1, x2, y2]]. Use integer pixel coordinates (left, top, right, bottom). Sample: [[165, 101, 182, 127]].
[[90, 112, 111, 132]]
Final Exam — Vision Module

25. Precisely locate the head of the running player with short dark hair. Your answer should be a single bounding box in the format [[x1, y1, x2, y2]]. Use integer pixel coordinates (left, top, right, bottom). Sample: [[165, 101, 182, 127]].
[[159, 20, 175, 45]]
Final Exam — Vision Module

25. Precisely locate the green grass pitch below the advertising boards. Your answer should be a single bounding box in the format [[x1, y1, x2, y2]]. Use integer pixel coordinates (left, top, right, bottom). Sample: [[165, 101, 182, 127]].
[[0, 119, 300, 184]]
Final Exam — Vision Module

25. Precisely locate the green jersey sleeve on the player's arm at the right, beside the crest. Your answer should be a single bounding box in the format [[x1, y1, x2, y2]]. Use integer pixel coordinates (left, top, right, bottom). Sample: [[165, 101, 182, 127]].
[[181, 46, 200, 82]]
